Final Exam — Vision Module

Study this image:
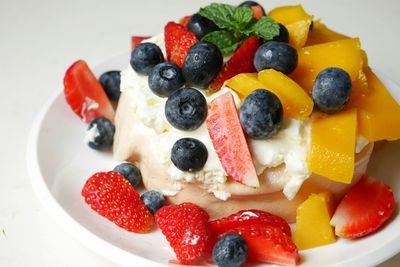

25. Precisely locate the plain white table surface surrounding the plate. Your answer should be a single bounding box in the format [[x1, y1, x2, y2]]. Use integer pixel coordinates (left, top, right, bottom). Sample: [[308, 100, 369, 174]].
[[0, 0, 400, 267]]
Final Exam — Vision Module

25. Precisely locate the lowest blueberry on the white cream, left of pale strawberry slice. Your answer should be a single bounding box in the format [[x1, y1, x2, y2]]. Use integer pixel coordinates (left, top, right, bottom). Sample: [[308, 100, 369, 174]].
[[171, 138, 208, 172]]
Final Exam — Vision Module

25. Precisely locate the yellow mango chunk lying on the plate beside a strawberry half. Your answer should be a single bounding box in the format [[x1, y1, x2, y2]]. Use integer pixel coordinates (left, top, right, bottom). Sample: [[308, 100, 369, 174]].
[[294, 192, 336, 250]]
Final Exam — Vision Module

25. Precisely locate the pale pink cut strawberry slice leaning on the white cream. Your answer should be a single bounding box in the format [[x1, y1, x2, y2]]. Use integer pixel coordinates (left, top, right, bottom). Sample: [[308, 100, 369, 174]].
[[206, 93, 260, 187]]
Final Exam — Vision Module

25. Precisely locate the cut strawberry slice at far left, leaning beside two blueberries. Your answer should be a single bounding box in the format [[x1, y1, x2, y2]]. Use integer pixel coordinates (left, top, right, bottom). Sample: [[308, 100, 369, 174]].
[[64, 60, 114, 123]]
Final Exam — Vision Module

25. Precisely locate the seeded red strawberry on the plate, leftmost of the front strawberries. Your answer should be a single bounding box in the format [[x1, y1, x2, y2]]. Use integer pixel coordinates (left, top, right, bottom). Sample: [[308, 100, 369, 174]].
[[82, 171, 154, 233]]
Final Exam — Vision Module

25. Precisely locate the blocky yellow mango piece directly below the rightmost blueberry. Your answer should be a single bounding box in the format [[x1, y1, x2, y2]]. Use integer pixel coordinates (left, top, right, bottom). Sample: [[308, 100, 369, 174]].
[[307, 109, 357, 184]]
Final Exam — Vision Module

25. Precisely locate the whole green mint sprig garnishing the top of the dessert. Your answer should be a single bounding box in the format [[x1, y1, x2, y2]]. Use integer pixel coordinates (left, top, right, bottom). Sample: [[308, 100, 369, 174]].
[[199, 3, 279, 55]]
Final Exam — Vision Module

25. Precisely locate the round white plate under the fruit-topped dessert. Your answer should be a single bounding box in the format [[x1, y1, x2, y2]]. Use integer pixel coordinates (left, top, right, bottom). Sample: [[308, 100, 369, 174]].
[[27, 54, 400, 267]]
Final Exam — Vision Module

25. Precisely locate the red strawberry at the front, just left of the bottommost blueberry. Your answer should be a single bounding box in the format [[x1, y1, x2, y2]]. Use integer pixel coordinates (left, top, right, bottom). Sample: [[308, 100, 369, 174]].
[[155, 203, 212, 264]]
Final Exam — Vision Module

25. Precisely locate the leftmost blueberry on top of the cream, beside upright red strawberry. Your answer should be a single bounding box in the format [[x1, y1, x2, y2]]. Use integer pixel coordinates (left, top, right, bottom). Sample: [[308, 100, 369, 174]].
[[131, 43, 164, 75]]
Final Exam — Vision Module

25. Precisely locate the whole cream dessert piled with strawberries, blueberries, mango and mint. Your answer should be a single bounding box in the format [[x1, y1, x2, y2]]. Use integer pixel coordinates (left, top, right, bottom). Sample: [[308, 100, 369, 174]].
[[60, 1, 400, 266]]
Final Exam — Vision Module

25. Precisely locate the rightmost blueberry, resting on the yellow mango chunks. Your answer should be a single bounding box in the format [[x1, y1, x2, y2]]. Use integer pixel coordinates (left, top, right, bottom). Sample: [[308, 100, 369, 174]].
[[311, 68, 351, 113]]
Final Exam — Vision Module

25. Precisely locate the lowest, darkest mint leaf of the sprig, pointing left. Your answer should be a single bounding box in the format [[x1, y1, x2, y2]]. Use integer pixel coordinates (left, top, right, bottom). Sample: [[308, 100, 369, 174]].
[[201, 31, 240, 55]]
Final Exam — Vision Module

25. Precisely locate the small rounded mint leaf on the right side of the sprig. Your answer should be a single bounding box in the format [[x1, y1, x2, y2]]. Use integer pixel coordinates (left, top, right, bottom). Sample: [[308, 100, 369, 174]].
[[241, 16, 279, 40]]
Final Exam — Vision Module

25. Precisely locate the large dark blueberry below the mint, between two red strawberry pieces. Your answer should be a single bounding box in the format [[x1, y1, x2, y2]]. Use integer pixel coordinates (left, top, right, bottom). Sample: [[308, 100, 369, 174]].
[[182, 42, 223, 88]]
